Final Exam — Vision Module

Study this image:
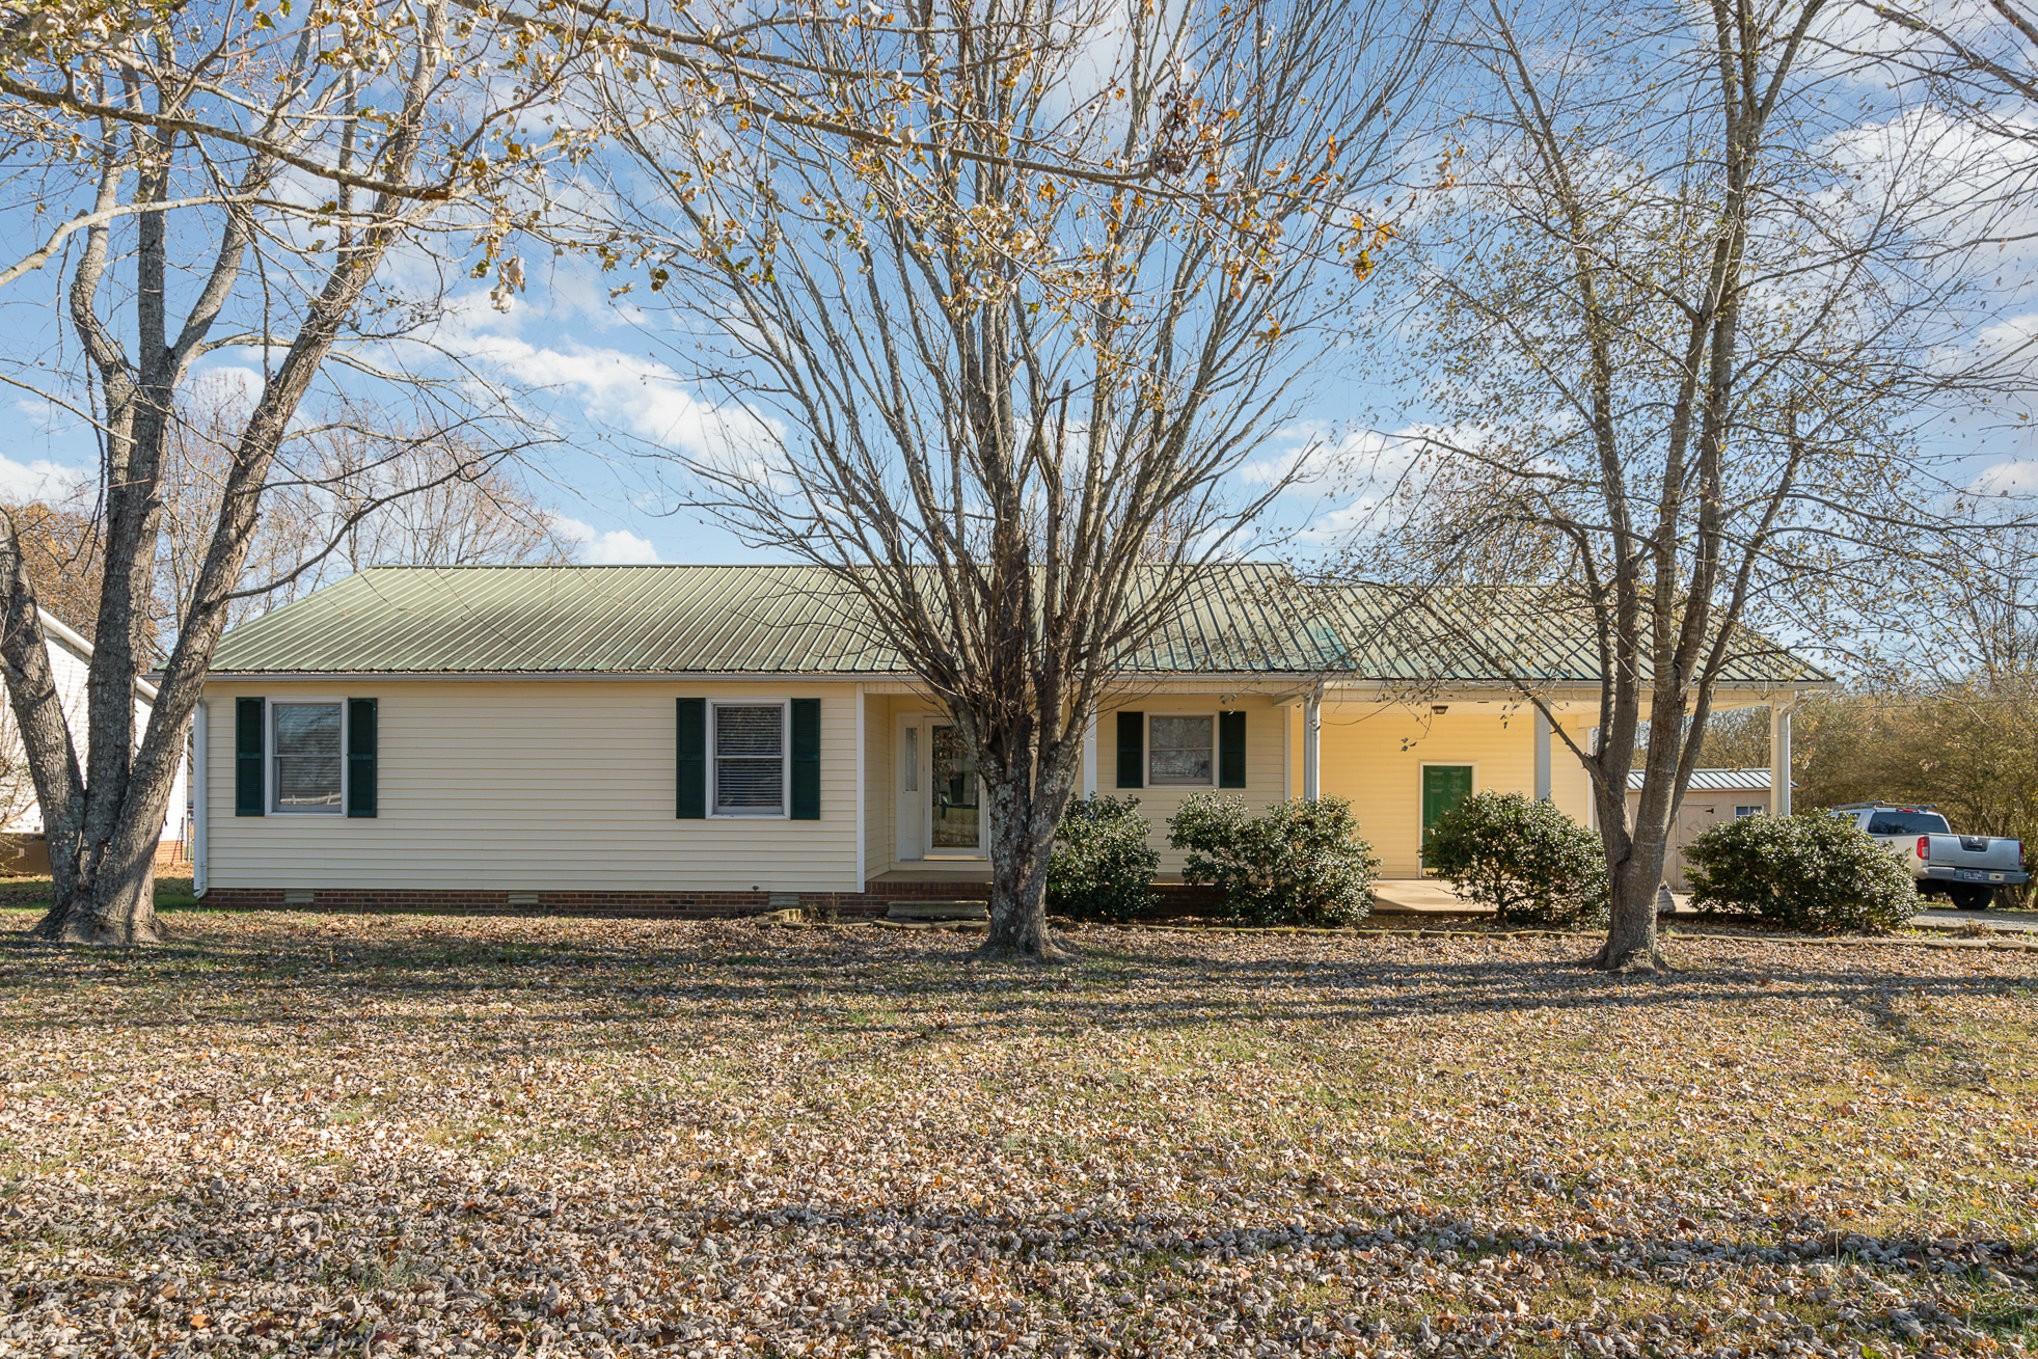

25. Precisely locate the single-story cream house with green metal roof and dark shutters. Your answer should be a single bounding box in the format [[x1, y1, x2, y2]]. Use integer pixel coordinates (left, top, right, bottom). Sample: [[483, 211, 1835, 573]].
[[194, 566, 1826, 911]]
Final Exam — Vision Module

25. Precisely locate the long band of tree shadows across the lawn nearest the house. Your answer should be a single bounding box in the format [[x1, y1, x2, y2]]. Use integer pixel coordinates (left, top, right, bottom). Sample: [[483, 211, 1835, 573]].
[[0, 917, 2038, 1059]]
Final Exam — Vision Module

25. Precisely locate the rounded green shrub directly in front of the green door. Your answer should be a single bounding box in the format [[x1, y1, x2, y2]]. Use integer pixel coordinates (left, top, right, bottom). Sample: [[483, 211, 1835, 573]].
[[1423, 793, 1610, 925]]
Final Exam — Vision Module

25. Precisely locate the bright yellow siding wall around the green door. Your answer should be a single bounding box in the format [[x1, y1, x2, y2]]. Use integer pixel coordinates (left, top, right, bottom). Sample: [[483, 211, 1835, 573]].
[[1290, 701, 1592, 878]]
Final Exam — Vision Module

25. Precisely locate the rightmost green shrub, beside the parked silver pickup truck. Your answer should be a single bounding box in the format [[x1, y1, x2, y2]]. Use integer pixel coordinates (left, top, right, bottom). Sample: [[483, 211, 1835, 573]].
[[1685, 813, 1918, 933]]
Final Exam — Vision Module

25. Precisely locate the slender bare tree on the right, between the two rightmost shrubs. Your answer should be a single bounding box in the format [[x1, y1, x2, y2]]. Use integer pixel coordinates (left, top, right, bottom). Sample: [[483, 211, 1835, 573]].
[[1361, 0, 2029, 968]]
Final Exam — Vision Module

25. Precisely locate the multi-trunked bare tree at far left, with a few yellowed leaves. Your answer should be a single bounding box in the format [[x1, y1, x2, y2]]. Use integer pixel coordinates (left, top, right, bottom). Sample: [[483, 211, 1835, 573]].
[[0, 0, 593, 941]]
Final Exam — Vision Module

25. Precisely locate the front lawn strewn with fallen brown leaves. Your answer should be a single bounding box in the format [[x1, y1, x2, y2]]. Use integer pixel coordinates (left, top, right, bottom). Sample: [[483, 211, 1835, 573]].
[[0, 911, 2038, 1357]]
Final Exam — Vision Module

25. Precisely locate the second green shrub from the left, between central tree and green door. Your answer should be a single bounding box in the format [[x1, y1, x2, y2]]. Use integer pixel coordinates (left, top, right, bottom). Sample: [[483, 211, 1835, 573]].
[[1168, 793, 1380, 925]]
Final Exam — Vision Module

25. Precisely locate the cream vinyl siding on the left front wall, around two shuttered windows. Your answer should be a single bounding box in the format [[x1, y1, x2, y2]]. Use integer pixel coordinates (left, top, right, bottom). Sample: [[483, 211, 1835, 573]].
[[206, 678, 862, 892]]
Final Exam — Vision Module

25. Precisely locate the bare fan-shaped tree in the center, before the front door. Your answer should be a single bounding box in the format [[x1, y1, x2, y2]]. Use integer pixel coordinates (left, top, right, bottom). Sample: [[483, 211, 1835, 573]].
[[591, 0, 1431, 958]]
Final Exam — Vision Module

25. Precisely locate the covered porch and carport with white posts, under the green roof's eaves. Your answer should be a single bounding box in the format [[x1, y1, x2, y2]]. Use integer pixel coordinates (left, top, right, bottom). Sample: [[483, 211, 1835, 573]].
[[860, 676, 1802, 894]]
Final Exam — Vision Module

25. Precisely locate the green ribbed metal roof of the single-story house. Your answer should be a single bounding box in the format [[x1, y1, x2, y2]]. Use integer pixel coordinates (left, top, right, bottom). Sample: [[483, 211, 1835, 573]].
[[212, 564, 1824, 685]]
